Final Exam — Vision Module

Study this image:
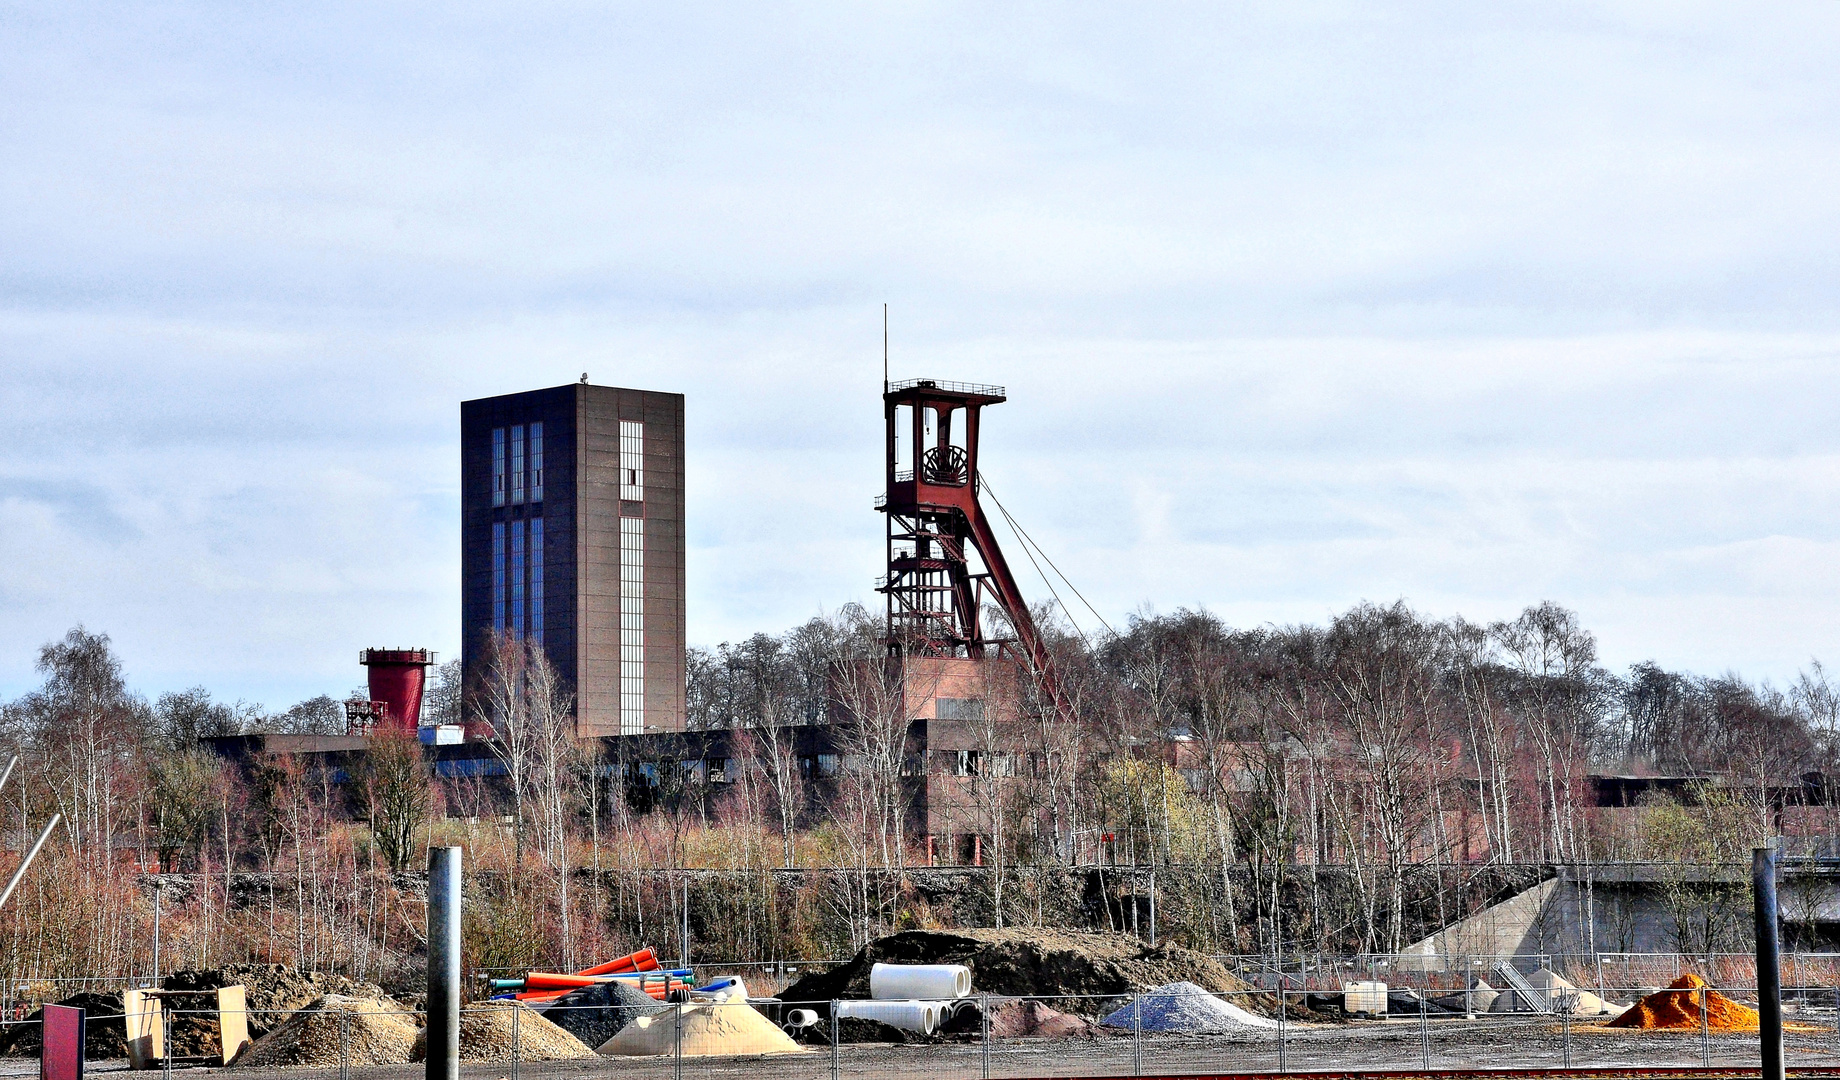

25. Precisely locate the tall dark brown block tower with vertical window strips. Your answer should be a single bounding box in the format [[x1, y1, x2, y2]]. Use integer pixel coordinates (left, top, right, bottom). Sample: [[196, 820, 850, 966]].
[[460, 375, 686, 738]]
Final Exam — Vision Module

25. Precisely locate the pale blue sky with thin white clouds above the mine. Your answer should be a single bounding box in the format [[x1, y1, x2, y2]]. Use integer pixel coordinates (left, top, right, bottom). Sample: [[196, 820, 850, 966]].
[[0, 0, 1840, 710]]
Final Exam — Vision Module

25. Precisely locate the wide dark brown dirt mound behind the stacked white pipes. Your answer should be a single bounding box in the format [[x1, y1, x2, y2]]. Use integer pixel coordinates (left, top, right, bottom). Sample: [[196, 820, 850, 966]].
[[780, 927, 1271, 1014]]
